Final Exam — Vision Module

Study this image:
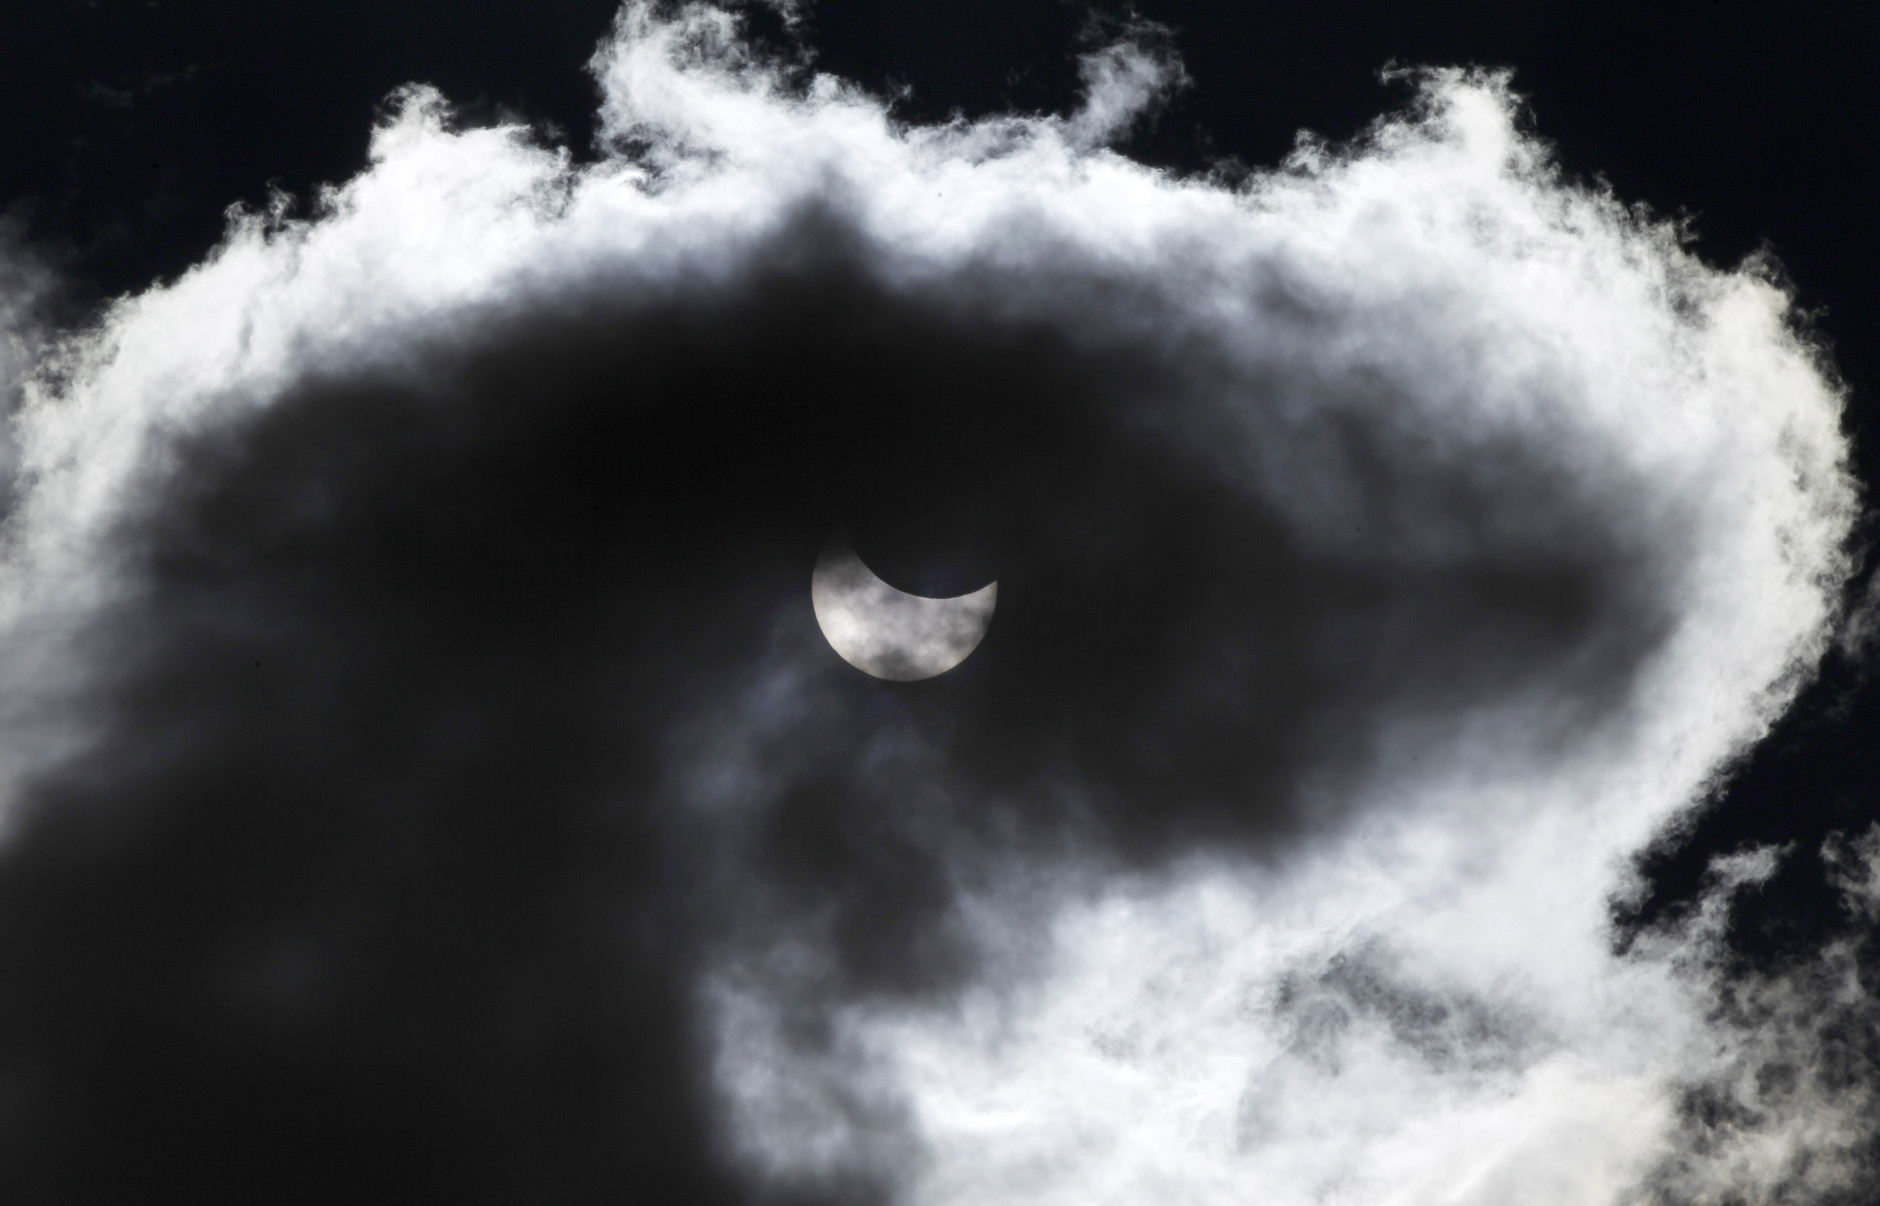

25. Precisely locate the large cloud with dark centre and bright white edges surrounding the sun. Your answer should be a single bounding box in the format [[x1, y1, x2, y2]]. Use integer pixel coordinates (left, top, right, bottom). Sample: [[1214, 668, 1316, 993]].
[[0, 4, 1871, 1202]]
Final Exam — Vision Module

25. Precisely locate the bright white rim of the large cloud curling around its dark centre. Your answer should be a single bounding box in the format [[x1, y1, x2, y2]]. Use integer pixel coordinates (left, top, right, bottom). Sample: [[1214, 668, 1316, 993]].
[[0, 4, 1872, 1206]]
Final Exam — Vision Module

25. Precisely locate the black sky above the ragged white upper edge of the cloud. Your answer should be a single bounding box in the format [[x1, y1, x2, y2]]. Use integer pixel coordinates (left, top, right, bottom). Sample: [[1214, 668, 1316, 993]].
[[14, 0, 1880, 382]]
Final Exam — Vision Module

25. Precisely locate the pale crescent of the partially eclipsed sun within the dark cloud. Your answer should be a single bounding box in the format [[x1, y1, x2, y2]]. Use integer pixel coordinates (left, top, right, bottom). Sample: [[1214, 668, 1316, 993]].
[[810, 531, 998, 683]]
